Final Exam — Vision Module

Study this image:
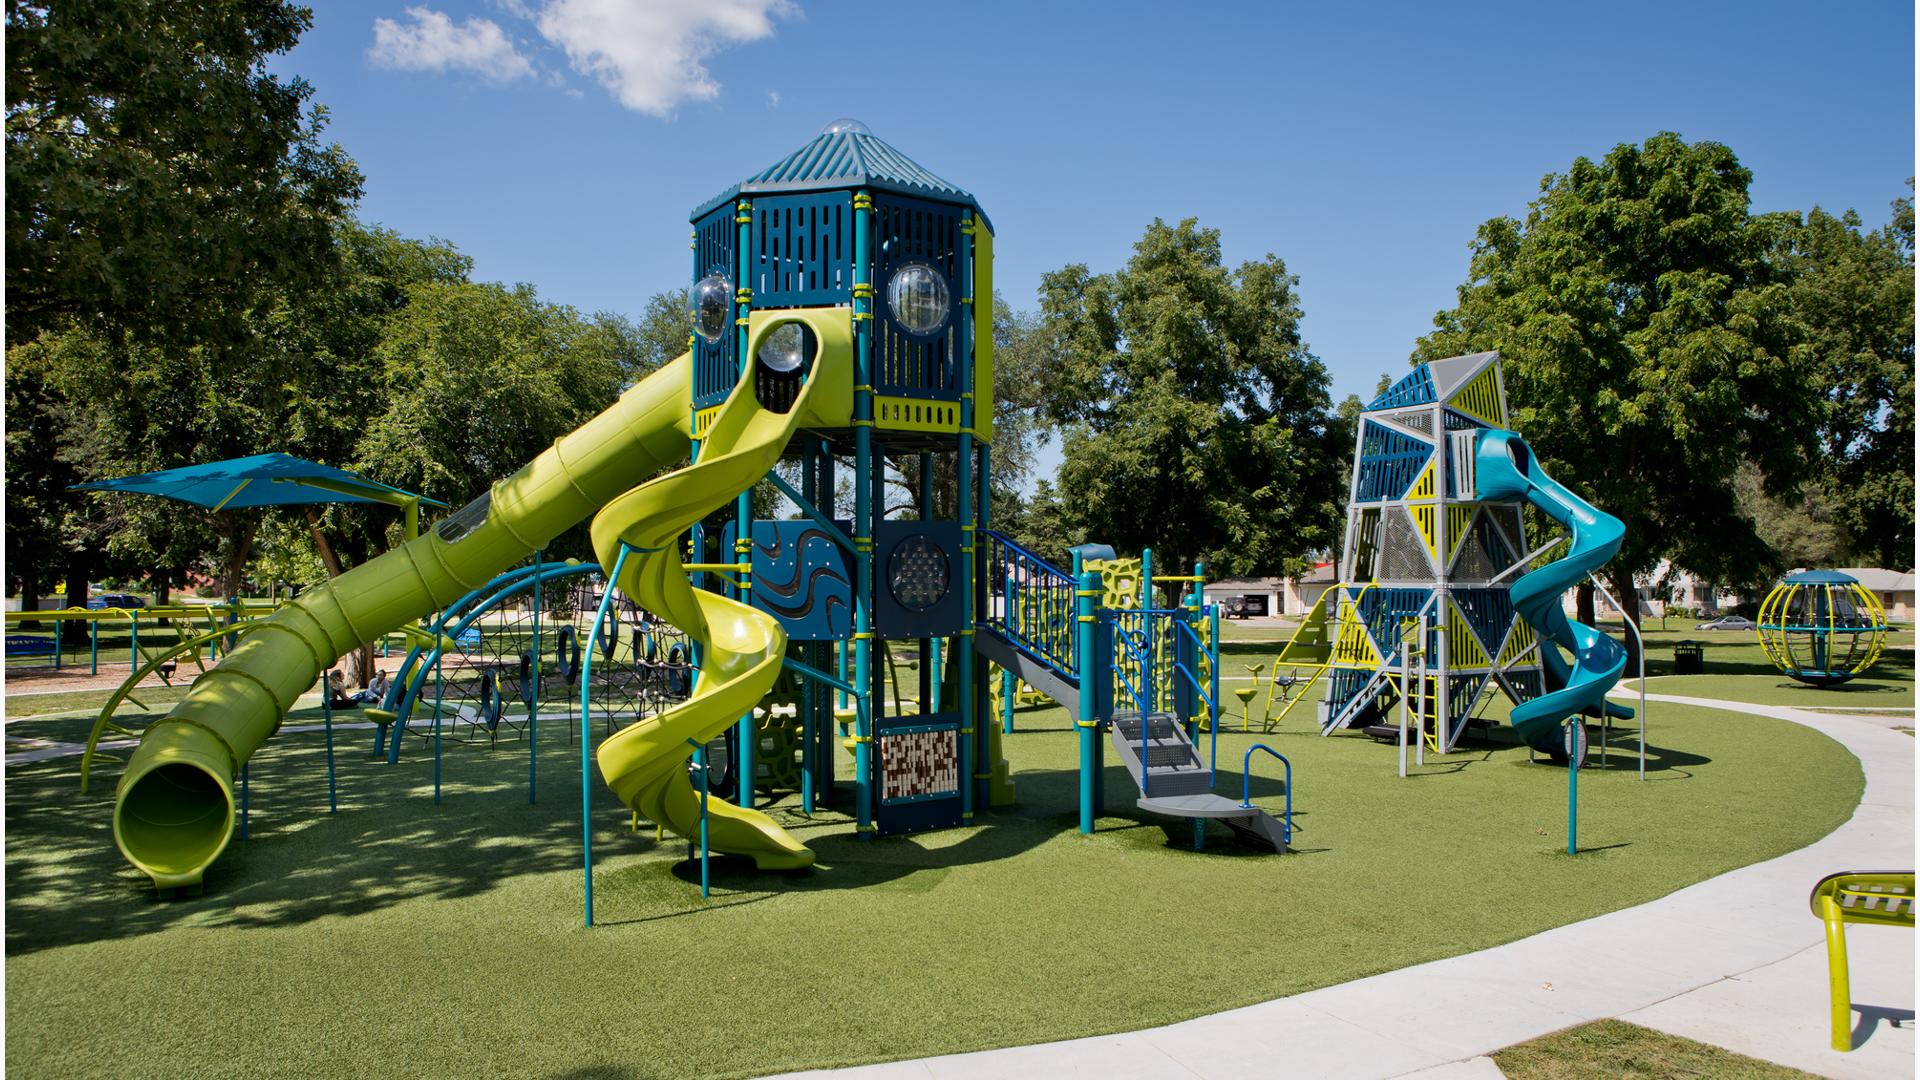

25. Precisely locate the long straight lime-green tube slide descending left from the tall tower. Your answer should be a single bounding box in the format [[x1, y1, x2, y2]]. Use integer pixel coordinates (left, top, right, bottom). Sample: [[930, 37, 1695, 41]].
[[113, 356, 698, 888]]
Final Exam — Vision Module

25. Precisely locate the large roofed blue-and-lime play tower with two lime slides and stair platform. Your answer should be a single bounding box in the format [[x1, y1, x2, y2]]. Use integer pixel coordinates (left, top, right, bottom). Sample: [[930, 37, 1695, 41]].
[[101, 121, 1292, 899]]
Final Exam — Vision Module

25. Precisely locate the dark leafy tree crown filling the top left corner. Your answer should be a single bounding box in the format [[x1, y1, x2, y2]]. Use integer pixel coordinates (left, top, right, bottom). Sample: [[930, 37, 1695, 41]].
[[6, 0, 361, 344]]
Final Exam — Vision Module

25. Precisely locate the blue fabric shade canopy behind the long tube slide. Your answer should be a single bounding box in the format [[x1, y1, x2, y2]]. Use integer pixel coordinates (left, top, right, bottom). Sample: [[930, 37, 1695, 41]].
[[73, 454, 447, 509]]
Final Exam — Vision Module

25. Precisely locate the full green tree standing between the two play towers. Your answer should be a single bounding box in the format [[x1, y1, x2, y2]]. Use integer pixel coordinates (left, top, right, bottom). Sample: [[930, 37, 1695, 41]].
[[1029, 219, 1350, 575]]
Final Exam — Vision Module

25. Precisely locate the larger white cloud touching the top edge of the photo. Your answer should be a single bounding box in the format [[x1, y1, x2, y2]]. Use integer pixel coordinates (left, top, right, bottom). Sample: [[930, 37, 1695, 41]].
[[534, 0, 799, 117]]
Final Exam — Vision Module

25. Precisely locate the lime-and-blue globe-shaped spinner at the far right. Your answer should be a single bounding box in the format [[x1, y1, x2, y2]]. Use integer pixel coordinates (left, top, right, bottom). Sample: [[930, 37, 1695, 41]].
[[1759, 571, 1887, 686]]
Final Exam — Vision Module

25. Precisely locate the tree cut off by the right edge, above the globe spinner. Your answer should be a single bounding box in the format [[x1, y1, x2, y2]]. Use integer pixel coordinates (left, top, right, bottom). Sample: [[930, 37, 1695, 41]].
[[1784, 189, 1914, 569]]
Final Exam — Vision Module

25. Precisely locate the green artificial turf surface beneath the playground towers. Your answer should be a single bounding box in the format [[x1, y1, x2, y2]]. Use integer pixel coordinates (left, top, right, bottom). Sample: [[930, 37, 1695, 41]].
[[6, 642, 1862, 1078]]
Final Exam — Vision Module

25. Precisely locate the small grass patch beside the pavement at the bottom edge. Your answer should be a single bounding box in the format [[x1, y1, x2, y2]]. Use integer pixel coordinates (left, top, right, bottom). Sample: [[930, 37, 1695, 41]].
[[1494, 1020, 1812, 1080]]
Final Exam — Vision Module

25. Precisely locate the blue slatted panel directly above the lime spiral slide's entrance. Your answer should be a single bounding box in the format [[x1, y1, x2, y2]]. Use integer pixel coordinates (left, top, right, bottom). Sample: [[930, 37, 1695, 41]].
[[747, 192, 852, 309]]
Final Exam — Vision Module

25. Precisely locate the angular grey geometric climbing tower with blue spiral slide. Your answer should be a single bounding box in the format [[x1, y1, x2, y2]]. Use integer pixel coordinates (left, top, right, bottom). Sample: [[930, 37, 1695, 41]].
[[1275, 352, 1645, 774]]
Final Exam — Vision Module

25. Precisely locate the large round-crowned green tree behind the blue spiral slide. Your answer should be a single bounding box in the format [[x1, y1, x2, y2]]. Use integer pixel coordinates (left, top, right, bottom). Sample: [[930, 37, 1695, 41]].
[[1415, 133, 1818, 657]]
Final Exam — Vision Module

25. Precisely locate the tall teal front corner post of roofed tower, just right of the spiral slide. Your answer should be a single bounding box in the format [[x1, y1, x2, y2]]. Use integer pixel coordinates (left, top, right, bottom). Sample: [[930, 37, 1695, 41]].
[[852, 190, 879, 840]]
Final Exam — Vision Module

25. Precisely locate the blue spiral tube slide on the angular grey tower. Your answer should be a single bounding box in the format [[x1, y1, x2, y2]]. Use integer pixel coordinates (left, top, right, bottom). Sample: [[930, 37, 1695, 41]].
[[1475, 429, 1634, 755]]
